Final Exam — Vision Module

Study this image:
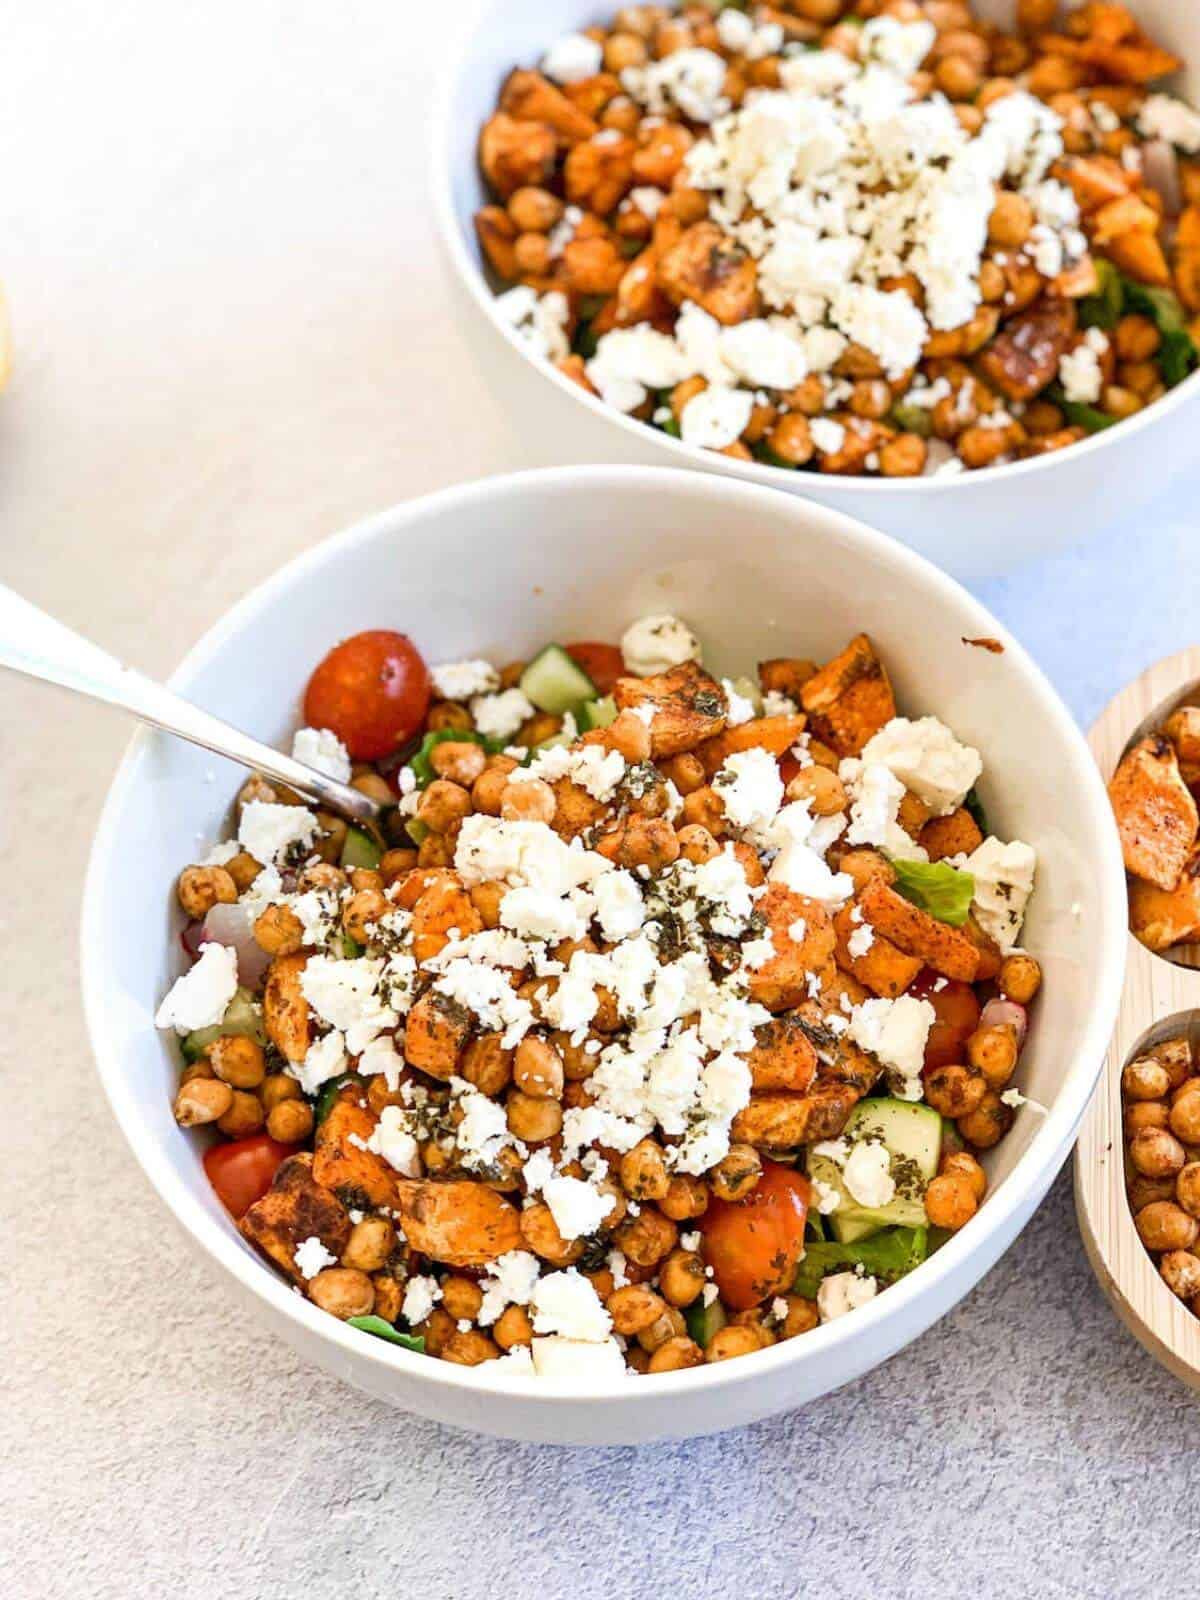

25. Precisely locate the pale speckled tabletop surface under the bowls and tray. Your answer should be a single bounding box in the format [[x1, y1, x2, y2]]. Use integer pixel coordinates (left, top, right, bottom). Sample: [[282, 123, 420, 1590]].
[[0, 0, 1200, 1600]]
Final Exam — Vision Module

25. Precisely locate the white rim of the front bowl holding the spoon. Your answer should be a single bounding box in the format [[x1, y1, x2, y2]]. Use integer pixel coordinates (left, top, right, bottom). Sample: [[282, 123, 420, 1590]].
[[80, 464, 1126, 1406]]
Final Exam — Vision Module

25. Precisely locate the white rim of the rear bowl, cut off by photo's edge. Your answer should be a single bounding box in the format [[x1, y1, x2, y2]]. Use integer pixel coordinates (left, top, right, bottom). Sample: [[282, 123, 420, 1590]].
[[427, 0, 1200, 501]]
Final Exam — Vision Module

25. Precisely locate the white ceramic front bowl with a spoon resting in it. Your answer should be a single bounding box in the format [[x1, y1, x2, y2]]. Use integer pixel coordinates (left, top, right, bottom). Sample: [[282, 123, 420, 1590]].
[[83, 467, 1125, 1443]]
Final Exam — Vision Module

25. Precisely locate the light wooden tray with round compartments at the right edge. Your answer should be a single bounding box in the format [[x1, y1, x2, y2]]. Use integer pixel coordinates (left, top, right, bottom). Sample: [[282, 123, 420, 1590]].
[[1075, 646, 1200, 1389]]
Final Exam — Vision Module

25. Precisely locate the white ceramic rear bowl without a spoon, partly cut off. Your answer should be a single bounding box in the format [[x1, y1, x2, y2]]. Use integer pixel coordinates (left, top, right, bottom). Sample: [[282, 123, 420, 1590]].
[[432, 0, 1200, 578]]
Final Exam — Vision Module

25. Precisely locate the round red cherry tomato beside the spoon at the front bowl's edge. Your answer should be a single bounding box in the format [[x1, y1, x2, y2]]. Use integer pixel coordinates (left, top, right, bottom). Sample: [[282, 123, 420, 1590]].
[[304, 627, 430, 762]]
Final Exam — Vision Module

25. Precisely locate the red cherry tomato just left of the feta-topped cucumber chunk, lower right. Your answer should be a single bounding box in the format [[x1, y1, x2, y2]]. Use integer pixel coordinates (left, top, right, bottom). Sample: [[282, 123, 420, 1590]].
[[698, 1162, 813, 1310]]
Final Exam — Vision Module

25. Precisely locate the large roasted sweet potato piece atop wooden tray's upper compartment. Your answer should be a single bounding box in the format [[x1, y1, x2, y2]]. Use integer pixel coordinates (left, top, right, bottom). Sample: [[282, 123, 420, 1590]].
[[1109, 733, 1200, 890]]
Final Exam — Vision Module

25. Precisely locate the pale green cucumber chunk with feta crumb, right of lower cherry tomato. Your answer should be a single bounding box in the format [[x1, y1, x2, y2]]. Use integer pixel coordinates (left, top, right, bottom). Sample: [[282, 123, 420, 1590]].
[[808, 1099, 942, 1245]]
